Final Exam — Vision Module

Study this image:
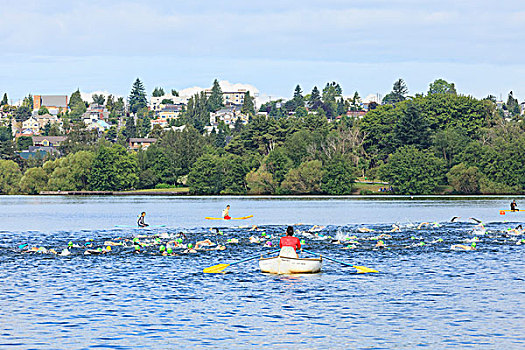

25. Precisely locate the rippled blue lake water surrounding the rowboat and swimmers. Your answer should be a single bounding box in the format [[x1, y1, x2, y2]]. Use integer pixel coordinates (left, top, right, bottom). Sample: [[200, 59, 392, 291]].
[[0, 196, 525, 349]]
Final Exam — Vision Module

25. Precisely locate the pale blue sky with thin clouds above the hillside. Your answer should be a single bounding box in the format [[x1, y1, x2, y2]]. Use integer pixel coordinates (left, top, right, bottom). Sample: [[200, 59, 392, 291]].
[[0, 0, 525, 102]]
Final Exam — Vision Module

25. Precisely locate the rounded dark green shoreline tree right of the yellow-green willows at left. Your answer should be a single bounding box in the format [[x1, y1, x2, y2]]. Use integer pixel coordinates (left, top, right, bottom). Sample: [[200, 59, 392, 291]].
[[89, 145, 139, 191]]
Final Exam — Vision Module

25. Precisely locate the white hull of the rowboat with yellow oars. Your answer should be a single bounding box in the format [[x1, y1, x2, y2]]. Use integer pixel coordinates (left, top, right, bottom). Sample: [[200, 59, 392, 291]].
[[259, 256, 323, 274]]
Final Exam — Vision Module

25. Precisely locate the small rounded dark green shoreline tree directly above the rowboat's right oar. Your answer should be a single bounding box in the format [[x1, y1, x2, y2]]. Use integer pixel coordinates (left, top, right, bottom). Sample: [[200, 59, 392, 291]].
[[321, 156, 356, 195]]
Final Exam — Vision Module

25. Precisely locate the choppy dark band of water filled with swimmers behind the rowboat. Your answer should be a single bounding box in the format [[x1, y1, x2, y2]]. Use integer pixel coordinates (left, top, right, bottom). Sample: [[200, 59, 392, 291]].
[[0, 222, 525, 257]]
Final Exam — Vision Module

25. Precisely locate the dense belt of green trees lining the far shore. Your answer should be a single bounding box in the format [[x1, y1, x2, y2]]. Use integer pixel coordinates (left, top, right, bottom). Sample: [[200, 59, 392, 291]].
[[0, 79, 525, 195]]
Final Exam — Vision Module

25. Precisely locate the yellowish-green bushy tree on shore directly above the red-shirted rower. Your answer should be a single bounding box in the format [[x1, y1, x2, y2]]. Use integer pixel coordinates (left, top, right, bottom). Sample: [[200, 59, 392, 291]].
[[281, 160, 324, 194]]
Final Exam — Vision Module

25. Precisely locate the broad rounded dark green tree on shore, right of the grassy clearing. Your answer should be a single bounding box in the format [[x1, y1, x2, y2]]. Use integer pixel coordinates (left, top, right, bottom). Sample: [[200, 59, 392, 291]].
[[379, 146, 445, 194]]
